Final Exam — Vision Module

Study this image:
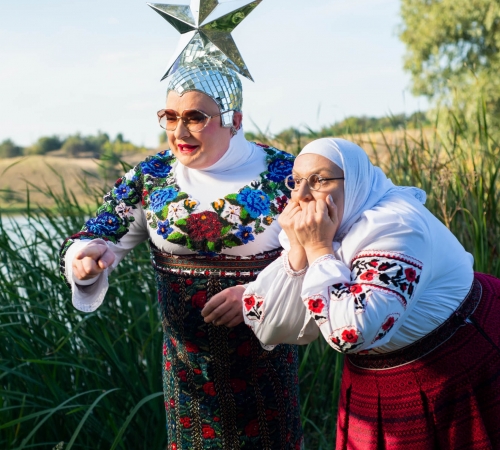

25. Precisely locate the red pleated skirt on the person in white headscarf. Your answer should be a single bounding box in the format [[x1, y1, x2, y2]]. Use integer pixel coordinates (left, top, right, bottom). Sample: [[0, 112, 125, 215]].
[[336, 274, 500, 450]]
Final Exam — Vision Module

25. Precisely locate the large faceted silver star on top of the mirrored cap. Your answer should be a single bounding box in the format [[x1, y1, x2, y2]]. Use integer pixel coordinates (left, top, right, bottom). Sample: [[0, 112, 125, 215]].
[[148, 0, 262, 81]]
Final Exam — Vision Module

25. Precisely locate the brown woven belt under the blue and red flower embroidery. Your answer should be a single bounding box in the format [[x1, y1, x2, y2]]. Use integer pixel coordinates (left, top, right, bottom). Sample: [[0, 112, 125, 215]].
[[150, 242, 282, 278]]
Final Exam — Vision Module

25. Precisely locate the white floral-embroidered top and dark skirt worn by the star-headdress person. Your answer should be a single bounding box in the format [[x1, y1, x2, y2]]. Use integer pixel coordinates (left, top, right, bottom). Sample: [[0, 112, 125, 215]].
[[61, 139, 302, 450]]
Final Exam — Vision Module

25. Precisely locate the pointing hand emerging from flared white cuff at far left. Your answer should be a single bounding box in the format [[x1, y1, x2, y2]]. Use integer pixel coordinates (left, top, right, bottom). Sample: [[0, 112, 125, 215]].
[[72, 239, 116, 280]]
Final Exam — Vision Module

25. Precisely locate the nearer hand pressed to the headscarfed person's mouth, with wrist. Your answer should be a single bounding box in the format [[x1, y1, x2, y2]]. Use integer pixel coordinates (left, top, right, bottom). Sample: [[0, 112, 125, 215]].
[[294, 196, 339, 264]]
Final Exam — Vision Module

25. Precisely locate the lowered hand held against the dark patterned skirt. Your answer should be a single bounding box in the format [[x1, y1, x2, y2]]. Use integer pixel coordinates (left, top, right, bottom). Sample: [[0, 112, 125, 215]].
[[201, 286, 245, 328]]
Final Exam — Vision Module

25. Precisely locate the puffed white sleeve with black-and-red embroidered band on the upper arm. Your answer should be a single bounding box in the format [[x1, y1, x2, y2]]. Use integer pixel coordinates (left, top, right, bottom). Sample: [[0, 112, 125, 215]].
[[301, 212, 431, 353]]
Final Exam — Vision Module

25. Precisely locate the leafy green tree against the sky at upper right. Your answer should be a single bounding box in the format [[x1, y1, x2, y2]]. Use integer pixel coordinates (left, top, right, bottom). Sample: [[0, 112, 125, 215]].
[[400, 0, 500, 123]]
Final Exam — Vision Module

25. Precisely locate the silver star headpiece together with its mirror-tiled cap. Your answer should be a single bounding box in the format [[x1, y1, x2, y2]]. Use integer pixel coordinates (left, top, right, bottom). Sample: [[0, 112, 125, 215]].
[[148, 0, 262, 127]]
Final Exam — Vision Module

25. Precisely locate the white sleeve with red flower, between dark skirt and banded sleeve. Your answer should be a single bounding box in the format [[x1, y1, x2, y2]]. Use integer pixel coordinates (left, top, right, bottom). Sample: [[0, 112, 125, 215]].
[[243, 251, 319, 350]]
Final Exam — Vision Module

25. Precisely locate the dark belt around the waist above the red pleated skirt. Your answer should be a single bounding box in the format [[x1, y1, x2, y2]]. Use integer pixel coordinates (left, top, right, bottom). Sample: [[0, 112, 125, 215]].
[[348, 279, 483, 370]]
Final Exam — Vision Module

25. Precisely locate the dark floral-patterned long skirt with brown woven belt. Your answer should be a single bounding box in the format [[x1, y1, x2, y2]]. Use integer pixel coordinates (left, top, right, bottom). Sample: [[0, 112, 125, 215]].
[[152, 248, 303, 450]]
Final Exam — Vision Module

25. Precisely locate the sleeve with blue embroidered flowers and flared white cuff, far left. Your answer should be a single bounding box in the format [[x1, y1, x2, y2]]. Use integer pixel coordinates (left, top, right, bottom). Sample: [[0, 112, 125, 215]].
[[60, 168, 148, 312]]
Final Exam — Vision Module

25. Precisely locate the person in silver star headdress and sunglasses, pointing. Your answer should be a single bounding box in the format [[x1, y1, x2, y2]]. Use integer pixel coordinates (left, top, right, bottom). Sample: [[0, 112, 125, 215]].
[[61, 0, 304, 450]]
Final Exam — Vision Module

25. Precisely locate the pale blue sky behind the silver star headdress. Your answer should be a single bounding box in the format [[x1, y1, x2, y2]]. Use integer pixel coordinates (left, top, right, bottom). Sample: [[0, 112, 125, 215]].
[[0, 0, 427, 146]]
